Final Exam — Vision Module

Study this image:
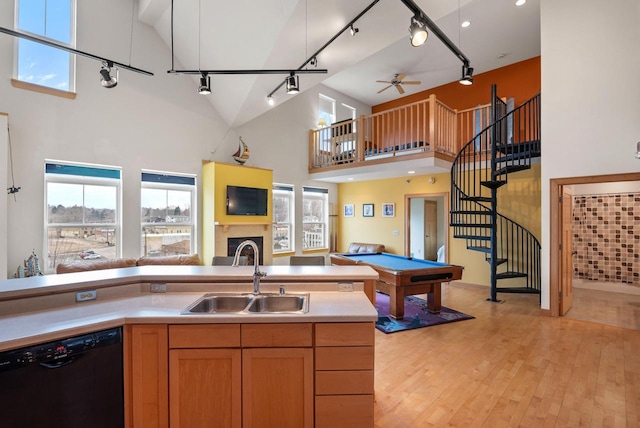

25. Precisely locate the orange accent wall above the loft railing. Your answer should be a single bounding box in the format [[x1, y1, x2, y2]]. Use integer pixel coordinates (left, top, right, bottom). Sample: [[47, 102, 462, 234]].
[[371, 56, 541, 113]]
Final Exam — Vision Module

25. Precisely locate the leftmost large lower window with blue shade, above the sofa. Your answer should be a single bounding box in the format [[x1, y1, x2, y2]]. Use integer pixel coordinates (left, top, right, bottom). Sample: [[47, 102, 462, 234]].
[[44, 162, 122, 272]]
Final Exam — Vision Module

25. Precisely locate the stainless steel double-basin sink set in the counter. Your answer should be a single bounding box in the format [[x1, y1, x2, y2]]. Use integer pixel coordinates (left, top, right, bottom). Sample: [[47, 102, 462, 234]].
[[180, 293, 309, 315]]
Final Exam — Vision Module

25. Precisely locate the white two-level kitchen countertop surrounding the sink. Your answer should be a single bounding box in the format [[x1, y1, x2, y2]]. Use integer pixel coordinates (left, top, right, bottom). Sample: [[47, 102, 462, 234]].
[[0, 266, 378, 350]]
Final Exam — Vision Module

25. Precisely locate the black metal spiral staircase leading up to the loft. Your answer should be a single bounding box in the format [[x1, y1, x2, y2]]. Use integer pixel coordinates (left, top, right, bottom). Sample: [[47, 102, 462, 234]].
[[450, 85, 541, 302]]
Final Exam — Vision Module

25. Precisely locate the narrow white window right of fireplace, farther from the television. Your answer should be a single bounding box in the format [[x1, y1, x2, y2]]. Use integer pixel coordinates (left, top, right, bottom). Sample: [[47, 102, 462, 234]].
[[302, 187, 329, 250]]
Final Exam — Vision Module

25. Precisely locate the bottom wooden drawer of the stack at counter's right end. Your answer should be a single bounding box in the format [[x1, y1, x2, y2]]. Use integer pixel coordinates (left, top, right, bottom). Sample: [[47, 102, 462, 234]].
[[315, 395, 373, 428]]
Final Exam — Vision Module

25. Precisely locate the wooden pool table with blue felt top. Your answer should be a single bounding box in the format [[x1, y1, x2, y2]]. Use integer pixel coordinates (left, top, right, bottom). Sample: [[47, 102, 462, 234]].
[[331, 253, 462, 319]]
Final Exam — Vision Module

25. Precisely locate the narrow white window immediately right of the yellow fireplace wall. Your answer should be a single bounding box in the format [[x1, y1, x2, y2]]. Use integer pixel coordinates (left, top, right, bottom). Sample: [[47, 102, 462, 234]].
[[273, 184, 295, 254]]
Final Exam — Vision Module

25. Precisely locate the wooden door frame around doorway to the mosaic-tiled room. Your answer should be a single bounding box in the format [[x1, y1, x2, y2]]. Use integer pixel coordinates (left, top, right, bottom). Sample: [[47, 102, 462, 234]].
[[549, 172, 640, 317]]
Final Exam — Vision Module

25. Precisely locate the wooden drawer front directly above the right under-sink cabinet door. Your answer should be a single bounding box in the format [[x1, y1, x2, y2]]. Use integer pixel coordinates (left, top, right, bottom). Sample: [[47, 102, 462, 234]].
[[242, 323, 313, 348]]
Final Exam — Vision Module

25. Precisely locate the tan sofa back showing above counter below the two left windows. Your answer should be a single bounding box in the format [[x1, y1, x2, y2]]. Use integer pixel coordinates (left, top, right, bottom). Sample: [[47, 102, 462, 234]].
[[56, 254, 202, 273]]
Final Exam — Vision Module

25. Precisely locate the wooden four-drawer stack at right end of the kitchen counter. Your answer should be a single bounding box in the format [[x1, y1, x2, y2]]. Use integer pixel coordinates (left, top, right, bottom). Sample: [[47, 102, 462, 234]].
[[315, 323, 374, 428]]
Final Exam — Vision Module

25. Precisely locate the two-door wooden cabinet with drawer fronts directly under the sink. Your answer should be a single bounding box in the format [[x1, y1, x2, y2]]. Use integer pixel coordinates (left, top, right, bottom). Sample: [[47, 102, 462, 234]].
[[169, 323, 313, 428]]
